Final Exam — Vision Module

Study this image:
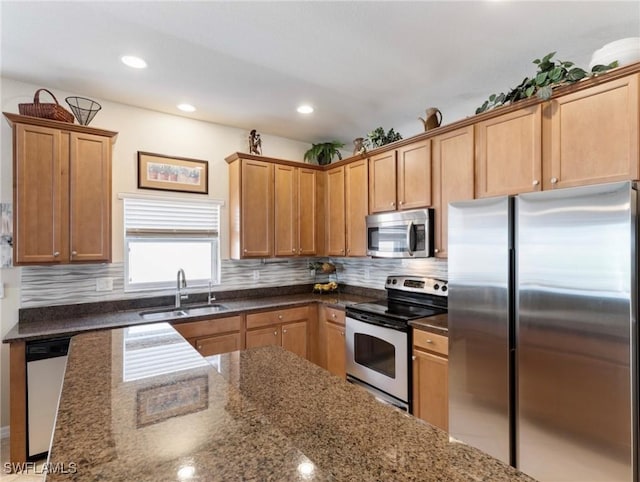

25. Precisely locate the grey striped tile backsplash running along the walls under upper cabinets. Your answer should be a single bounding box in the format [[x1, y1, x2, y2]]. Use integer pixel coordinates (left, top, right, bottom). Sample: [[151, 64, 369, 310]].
[[21, 258, 447, 308]]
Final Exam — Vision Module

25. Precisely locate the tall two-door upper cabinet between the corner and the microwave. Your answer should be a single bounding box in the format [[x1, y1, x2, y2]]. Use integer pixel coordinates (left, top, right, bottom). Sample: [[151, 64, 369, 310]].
[[326, 159, 368, 256]]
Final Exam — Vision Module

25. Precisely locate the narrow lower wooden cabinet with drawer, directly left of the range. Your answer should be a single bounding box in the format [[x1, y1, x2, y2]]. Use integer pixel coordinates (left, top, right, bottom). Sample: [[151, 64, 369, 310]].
[[320, 305, 346, 378]]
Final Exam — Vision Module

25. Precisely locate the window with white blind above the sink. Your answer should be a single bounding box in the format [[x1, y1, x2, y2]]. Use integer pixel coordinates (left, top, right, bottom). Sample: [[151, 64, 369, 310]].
[[124, 197, 221, 291]]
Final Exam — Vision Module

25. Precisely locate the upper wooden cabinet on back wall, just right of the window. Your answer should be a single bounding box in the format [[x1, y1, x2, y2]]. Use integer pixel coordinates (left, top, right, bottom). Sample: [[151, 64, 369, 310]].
[[226, 153, 324, 259]]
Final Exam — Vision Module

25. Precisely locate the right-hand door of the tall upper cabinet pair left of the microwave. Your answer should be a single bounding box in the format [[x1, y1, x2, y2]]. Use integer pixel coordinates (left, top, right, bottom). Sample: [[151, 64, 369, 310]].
[[345, 160, 369, 256]]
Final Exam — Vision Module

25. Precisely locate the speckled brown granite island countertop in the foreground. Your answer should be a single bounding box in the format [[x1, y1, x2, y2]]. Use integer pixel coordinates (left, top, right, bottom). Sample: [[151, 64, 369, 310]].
[[47, 323, 533, 482]]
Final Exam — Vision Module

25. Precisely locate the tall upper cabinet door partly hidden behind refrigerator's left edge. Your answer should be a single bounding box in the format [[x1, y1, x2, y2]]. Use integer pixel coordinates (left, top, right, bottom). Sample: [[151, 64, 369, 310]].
[[432, 126, 474, 258]]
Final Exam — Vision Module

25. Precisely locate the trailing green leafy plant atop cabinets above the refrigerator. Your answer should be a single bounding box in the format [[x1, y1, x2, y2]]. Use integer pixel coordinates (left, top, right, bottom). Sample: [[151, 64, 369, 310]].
[[476, 52, 618, 114]]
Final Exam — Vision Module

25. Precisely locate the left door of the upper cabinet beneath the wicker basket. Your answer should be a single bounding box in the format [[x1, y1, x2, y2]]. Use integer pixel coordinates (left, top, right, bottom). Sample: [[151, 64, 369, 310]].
[[13, 124, 63, 265]]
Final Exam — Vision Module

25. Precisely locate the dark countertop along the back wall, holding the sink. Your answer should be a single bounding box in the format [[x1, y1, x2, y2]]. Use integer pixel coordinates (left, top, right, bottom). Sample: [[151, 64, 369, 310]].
[[3, 293, 371, 343]]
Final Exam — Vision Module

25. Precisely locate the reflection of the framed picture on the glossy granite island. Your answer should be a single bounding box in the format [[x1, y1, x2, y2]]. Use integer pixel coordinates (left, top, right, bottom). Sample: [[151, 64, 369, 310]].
[[136, 375, 209, 428]]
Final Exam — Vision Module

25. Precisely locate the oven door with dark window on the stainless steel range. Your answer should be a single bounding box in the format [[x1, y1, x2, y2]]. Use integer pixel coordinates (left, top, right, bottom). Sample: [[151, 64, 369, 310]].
[[345, 317, 409, 404]]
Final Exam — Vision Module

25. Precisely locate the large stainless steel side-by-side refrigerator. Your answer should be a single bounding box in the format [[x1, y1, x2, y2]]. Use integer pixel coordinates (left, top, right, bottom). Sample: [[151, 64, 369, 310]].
[[448, 182, 638, 482]]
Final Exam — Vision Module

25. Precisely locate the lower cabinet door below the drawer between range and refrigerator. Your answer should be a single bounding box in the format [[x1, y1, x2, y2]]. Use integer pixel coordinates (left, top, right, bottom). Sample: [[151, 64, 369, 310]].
[[413, 349, 449, 430]]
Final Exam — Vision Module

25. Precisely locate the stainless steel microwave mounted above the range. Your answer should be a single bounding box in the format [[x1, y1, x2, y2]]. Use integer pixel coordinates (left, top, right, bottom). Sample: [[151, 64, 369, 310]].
[[367, 209, 433, 258]]
